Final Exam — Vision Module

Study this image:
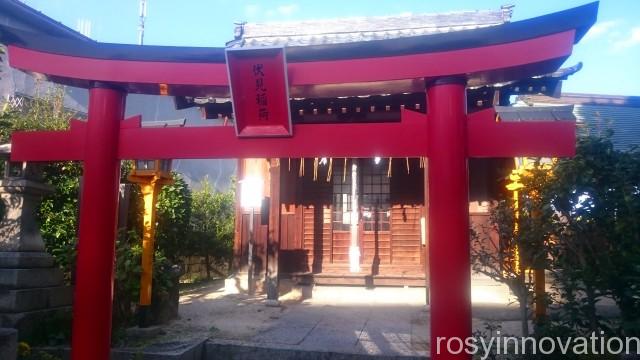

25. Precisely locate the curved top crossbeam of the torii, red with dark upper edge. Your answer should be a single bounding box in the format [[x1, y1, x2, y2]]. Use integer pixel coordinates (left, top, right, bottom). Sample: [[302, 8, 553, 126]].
[[2, 3, 597, 96]]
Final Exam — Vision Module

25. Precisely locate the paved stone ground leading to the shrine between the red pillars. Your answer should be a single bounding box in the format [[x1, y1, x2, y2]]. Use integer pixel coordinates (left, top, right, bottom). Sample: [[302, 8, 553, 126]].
[[144, 282, 519, 356]]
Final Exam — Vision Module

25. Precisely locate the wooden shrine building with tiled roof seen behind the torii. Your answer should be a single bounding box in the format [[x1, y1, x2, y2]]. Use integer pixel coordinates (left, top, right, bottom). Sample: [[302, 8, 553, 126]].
[[194, 6, 580, 288]]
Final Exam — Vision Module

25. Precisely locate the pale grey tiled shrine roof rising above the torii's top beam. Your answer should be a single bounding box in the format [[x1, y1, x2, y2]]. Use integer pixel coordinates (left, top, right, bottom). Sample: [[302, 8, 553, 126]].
[[227, 6, 513, 47]]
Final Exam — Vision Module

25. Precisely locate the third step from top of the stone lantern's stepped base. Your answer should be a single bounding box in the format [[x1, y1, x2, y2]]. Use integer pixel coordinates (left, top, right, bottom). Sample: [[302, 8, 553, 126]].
[[0, 286, 73, 313]]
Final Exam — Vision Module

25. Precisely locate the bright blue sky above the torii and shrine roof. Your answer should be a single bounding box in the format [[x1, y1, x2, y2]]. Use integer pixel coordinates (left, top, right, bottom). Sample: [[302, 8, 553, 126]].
[[24, 0, 640, 96]]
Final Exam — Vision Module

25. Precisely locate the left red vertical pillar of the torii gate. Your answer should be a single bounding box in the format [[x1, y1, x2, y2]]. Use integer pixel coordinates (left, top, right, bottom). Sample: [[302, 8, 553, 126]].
[[71, 85, 126, 360]]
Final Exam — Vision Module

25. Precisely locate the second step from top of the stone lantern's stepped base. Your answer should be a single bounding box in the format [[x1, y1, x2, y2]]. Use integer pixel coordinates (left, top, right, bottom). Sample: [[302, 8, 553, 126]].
[[0, 268, 63, 289]]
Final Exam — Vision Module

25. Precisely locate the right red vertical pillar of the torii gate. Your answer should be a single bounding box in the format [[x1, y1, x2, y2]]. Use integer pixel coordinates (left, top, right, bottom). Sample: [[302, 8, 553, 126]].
[[426, 77, 471, 360]]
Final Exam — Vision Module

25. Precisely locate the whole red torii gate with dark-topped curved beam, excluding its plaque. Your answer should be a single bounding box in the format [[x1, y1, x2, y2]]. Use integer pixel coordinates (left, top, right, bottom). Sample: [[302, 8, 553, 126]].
[[0, 3, 598, 360]]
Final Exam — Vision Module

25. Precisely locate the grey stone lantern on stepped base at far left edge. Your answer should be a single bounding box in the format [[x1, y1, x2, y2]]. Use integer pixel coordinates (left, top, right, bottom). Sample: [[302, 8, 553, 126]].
[[0, 144, 72, 338]]
